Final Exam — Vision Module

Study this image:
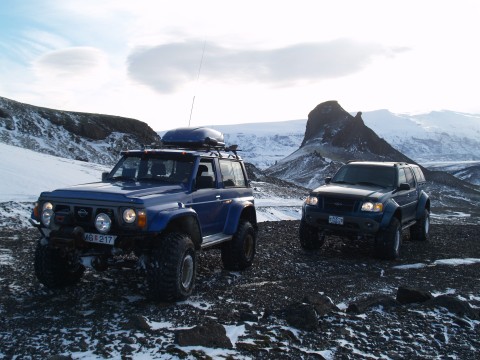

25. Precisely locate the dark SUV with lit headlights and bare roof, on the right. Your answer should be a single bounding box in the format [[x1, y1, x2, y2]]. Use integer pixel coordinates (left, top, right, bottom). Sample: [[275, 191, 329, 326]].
[[300, 161, 430, 259]]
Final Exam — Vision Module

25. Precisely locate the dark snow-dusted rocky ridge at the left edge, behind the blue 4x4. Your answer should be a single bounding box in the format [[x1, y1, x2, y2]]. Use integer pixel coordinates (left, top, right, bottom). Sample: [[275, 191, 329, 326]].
[[0, 97, 159, 165]]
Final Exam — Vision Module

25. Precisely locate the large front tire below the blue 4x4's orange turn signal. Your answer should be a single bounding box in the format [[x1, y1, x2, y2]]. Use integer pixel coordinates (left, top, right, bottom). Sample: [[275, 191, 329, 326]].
[[147, 232, 197, 302]]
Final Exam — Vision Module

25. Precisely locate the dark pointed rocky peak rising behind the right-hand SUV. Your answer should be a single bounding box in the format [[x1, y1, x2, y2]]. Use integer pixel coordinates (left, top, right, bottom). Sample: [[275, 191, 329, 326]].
[[267, 101, 414, 188]]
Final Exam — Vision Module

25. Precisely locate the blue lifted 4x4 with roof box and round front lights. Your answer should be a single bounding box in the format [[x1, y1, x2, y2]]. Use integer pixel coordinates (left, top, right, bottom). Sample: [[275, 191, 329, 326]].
[[31, 128, 257, 301]]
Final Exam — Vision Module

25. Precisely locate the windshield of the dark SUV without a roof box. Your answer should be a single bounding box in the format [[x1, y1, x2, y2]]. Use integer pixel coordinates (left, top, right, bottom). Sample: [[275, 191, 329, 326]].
[[331, 165, 395, 188]]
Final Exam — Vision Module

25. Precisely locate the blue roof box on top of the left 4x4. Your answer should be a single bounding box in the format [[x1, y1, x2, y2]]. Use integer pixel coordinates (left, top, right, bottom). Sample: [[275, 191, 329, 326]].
[[162, 127, 225, 148]]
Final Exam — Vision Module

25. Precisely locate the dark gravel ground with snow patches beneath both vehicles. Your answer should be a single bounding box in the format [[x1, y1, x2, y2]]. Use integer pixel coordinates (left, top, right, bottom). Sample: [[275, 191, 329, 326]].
[[0, 221, 480, 359]]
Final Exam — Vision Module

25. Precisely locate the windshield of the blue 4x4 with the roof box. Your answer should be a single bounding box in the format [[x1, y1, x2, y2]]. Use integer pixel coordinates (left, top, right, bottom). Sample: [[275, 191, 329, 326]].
[[108, 154, 193, 184]]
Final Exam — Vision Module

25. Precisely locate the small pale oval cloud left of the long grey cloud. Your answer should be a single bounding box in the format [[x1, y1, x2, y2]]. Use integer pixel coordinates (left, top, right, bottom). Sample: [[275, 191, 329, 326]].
[[34, 47, 107, 77]]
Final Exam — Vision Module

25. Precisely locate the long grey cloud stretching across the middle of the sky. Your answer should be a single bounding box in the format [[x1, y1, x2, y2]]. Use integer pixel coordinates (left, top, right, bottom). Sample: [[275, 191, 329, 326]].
[[128, 39, 402, 93]]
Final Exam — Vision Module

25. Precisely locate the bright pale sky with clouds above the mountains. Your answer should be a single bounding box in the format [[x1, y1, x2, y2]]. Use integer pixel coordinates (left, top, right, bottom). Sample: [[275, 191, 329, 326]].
[[0, 0, 480, 131]]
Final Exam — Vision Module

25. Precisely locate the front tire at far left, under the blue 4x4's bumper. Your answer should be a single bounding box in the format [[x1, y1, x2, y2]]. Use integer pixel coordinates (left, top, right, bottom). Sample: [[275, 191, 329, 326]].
[[34, 241, 85, 289]]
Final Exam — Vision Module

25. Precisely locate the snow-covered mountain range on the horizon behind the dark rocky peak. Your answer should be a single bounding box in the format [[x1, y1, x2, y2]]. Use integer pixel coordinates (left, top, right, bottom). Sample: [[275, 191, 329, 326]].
[[200, 106, 480, 174]]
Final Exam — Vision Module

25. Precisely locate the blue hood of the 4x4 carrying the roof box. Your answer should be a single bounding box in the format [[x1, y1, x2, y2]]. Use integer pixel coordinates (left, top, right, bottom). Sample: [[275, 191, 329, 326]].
[[42, 181, 186, 201]]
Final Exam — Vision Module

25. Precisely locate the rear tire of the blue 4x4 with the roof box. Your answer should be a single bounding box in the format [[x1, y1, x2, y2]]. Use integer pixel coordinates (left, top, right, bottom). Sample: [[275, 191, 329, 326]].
[[222, 221, 257, 271]]
